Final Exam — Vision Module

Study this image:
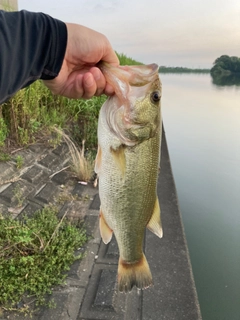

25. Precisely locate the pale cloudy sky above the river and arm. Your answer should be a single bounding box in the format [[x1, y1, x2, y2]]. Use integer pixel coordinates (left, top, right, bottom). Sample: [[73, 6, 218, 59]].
[[18, 0, 240, 68]]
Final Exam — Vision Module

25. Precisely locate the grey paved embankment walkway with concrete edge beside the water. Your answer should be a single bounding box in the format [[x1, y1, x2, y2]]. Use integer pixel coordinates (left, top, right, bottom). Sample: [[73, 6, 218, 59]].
[[0, 131, 201, 320]]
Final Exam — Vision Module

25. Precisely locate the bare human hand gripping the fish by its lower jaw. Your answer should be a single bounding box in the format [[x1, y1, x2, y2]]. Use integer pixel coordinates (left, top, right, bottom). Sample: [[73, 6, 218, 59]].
[[44, 23, 119, 99]]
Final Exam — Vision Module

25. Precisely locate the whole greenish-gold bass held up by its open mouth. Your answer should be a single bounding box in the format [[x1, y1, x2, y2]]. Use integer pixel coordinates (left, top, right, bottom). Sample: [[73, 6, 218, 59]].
[[95, 62, 163, 293]]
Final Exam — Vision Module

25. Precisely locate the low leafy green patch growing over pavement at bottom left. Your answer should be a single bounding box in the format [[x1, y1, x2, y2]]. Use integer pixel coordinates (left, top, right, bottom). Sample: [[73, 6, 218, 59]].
[[0, 207, 87, 311]]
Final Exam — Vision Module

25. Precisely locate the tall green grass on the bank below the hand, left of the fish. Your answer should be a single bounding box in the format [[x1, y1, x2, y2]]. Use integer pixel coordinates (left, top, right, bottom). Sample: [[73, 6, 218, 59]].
[[0, 81, 106, 148]]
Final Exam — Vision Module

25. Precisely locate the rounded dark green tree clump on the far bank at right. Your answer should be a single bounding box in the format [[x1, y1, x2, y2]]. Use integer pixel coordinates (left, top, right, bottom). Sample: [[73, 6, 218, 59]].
[[210, 55, 240, 76]]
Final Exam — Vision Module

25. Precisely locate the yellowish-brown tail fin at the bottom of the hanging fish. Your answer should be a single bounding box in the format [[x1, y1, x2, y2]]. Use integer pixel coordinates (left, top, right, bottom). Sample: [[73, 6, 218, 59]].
[[118, 254, 152, 292]]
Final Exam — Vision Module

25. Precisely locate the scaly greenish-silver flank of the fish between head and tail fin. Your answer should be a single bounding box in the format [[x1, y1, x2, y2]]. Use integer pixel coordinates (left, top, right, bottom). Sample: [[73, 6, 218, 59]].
[[99, 117, 159, 261]]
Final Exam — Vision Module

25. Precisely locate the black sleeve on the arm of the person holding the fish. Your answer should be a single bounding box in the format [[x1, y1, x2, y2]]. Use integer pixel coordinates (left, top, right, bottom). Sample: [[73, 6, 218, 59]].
[[0, 10, 67, 104]]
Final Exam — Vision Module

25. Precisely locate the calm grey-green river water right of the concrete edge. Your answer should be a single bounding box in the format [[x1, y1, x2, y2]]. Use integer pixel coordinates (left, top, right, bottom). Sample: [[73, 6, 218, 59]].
[[160, 74, 240, 320]]
